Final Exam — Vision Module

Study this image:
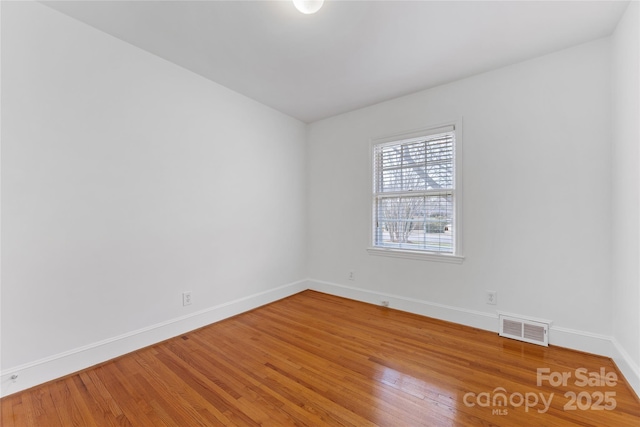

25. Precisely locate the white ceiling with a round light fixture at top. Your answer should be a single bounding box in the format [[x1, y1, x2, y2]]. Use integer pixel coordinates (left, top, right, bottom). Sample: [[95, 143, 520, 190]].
[[45, 0, 628, 122]]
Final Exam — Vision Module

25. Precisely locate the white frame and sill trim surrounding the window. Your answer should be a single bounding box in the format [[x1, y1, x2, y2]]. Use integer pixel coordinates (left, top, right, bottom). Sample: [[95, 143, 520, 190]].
[[367, 118, 464, 264]]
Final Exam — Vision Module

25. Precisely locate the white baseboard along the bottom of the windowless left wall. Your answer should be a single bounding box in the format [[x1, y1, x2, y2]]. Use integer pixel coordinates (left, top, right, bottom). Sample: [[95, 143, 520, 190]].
[[0, 280, 308, 396]]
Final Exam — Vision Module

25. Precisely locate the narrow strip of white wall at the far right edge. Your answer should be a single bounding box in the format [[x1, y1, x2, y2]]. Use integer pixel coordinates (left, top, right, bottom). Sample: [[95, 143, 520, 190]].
[[612, 2, 640, 390]]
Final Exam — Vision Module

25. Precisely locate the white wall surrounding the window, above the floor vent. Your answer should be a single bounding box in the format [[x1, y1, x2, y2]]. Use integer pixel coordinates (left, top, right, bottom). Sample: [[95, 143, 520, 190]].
[[308, 39, 612, 344]]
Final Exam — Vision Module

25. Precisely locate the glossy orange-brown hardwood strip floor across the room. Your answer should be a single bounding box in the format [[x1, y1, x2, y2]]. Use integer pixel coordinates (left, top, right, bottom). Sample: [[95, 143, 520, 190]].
[[1, 291, 640, 427]]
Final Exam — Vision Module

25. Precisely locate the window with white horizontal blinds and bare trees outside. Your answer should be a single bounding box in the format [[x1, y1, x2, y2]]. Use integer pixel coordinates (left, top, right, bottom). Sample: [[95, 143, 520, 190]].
[[369, 125, 462, 262]]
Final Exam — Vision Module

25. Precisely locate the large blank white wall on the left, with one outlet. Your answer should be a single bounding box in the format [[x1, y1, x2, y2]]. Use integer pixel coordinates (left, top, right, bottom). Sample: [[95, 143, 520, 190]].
[[2, 2, 306, 392]]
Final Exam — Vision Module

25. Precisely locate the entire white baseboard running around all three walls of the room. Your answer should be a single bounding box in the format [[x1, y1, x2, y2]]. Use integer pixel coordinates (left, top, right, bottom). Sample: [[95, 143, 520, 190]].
[[5, 280, 640, 402]]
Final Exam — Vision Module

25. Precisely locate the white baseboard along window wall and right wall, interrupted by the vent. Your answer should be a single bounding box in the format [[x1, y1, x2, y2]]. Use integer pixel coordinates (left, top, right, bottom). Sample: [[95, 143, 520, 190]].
[[308, 280, 640, 397]]
